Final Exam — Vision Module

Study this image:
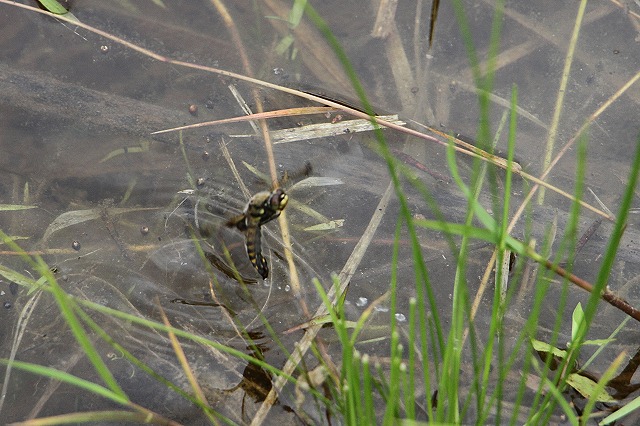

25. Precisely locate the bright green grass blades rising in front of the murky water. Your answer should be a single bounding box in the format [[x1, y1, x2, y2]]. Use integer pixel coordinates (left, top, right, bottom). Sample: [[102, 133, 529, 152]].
[[0, 1, 640, 425]]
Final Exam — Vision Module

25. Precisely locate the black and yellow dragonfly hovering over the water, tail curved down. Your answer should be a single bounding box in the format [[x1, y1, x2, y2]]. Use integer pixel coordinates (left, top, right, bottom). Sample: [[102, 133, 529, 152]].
[[227, 188, 289, 279]]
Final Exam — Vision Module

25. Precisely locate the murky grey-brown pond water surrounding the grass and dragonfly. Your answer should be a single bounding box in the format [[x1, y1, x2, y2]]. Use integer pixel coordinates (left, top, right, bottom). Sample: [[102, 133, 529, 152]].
[[0, 0, 640, 424]]
